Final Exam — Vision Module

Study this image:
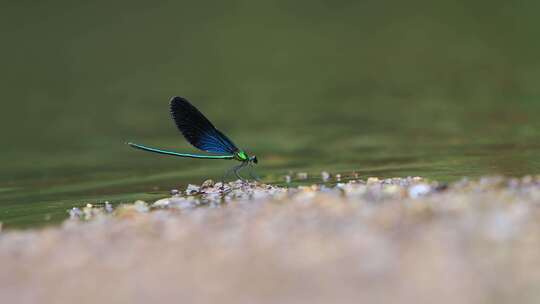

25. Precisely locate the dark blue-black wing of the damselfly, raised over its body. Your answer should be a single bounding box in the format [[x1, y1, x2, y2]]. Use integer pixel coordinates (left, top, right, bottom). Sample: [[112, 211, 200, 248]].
[[171, 96, 238, 154]]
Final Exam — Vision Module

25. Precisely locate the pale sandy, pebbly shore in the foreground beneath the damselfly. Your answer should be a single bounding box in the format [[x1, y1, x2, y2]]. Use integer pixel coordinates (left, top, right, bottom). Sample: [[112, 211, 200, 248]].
[[0, 177, 540, 304]]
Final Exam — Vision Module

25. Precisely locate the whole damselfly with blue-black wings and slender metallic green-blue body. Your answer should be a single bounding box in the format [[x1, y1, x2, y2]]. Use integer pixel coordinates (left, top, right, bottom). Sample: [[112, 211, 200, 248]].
[[128, 97, 258, 179]]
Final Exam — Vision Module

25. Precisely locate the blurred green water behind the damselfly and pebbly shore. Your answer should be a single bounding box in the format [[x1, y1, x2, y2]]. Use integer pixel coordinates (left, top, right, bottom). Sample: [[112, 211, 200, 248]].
[[0, 1, 540, 228]]
